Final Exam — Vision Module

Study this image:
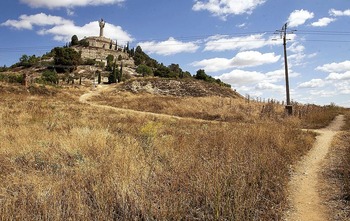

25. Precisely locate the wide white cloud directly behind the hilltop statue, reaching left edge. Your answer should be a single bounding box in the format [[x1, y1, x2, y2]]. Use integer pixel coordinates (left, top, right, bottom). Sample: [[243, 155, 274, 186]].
[[1, 13, 133, 43]]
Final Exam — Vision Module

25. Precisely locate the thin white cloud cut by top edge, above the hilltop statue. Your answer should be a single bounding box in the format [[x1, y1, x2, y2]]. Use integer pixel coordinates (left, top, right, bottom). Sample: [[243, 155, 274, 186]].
[[21, 0, 124, 9]]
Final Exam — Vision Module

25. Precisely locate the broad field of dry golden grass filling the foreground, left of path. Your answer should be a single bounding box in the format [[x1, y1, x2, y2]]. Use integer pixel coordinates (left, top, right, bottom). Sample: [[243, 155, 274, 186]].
[[0, 84, 344, 220]]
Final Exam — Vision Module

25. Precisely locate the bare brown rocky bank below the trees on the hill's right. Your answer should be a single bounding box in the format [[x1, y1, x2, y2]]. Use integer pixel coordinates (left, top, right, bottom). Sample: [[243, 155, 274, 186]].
[[120, 78, 242, 98]]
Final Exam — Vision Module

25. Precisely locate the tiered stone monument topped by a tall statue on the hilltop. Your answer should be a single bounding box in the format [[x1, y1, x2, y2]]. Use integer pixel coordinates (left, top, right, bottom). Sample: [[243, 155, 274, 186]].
[[72, 19, 134, 67]]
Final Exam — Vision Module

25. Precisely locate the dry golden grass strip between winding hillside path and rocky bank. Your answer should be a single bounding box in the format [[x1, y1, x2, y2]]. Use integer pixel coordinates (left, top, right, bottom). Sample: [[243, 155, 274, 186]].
[[91, 91, 284, 123]]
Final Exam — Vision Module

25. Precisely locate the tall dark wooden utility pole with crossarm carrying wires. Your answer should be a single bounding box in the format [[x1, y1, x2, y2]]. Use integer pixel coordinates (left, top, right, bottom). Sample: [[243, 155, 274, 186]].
[[276, 23, 295, 115]]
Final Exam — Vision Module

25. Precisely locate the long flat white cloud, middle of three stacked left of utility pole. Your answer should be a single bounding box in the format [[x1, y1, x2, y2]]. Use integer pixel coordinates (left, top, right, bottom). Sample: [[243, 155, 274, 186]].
[[192, 51, 281, 72]]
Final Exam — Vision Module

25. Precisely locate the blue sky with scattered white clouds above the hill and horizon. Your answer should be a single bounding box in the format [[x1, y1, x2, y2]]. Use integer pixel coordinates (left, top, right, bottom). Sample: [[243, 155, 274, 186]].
[[0, 0, 350, 107]]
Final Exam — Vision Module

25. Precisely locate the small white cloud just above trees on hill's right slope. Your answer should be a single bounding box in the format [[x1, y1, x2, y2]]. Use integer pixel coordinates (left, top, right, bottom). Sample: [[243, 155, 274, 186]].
[[139, 37, 199, 56]]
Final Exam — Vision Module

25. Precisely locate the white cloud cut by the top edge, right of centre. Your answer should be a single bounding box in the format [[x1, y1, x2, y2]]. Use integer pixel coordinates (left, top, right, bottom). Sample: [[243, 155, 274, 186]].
[[192, 0, 266, 19]]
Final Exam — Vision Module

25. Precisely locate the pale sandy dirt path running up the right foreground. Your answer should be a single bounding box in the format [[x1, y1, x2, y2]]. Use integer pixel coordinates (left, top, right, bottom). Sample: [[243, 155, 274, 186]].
[[286, 115, 344, 221]]
